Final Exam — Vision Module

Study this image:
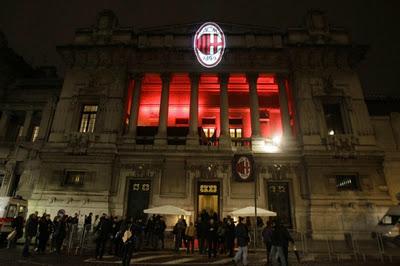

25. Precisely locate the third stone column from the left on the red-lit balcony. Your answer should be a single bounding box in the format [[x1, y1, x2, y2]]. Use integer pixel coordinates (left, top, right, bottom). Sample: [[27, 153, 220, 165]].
[[186, 73, 199, 145]]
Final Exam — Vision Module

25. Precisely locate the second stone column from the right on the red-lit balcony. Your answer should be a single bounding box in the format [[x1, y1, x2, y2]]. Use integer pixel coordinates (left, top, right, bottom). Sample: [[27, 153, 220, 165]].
[[247, 73, 261, 139]]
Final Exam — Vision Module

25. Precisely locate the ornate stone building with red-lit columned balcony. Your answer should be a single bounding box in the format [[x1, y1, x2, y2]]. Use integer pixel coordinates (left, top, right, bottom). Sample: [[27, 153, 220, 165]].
[[0, 11, 400, 236]]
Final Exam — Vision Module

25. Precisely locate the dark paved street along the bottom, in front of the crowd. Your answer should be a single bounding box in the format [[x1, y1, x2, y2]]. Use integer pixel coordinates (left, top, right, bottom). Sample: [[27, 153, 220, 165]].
[[0, 247, 399, 266]]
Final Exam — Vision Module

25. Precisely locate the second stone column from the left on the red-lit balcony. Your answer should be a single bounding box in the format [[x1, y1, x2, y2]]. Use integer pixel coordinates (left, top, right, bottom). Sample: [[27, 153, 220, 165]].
[[154, 73, 171, 145]]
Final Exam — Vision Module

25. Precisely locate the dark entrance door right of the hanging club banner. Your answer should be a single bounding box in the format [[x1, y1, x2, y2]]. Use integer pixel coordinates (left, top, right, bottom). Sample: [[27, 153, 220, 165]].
[[267, 182, 292, 228]]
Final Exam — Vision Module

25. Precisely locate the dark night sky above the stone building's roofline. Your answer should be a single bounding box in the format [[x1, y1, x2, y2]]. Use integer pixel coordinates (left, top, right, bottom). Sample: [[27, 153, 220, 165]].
[[0, 0, 400, 95]]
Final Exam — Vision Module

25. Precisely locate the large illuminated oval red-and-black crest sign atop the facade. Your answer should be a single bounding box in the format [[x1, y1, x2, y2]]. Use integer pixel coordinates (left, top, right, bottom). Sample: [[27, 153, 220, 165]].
[[193, 22, 225, 68]]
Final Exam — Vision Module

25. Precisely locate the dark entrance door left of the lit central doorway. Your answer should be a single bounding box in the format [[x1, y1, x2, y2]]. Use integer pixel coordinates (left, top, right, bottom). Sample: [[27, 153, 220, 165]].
[[126, 180, 151, 219]]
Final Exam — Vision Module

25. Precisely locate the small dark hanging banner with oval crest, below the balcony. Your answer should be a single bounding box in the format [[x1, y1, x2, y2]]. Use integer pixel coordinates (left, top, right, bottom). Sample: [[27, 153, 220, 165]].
[[232, 154, 254, 182]]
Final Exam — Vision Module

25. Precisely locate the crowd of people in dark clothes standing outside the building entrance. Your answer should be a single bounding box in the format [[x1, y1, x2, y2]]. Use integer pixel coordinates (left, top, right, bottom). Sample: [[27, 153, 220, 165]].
[[8, 210, 294, 265]]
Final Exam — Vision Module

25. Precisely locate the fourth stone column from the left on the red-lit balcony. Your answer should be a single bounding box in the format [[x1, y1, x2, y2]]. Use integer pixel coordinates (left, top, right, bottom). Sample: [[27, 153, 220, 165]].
[[219, 74, 231, 147]]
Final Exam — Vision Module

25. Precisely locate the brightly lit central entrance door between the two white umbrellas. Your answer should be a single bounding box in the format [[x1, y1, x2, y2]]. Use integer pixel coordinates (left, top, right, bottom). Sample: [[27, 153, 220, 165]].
[[197, 182, 219, 216]]
